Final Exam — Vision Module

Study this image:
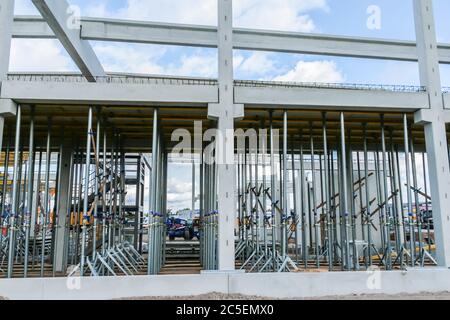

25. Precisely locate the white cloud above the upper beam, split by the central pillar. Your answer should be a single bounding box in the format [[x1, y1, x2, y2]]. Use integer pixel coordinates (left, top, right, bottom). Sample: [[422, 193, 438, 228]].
[[82, 0, 329, 32]]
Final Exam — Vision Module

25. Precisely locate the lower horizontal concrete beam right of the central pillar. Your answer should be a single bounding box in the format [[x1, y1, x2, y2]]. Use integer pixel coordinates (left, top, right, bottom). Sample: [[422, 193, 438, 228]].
[[235, 86, 428, 111]]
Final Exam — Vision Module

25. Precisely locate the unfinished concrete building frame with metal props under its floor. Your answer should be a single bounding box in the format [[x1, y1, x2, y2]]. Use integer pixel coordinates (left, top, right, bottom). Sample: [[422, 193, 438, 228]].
[[0, 0, 450, 299]]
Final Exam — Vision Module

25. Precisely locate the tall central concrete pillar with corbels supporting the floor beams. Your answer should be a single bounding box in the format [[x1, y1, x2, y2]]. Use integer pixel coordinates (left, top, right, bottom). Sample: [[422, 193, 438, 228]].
[[208, 0, 243, 271]]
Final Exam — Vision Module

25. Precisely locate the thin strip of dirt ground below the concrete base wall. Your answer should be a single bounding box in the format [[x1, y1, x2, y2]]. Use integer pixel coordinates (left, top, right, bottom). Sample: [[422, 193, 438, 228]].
[[125, 292, 450, 300]]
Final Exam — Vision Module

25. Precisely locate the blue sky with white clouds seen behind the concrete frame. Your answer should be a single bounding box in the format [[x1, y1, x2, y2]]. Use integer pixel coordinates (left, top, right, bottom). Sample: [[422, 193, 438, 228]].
[[10, 0, 450, 212]]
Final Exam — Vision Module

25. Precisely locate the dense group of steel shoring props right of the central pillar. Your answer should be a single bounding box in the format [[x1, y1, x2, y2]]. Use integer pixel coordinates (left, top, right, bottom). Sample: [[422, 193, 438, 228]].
[[236, 111, 437, 272]]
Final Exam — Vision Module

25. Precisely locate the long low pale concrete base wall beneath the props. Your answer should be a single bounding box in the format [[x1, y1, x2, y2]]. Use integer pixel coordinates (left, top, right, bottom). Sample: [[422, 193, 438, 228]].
[[0, 268, 450, 300]]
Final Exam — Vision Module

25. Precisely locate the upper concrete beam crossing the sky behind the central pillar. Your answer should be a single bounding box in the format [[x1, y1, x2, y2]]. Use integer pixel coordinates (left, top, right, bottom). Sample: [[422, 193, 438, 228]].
[[13, 16, 450, 64]]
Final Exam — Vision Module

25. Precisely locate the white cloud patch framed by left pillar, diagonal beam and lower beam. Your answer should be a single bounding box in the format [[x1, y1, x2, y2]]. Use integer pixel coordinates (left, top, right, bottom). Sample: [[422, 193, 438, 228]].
[[9, 39, 74, 71]]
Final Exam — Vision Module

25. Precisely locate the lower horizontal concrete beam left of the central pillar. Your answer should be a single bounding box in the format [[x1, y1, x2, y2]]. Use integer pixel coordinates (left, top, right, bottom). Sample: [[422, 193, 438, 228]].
[[1, 81, 219, 106]]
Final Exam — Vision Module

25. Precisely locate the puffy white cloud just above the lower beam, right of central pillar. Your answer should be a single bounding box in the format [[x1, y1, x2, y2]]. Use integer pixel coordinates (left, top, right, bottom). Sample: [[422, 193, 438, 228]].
[[273, 61, 345, 83]]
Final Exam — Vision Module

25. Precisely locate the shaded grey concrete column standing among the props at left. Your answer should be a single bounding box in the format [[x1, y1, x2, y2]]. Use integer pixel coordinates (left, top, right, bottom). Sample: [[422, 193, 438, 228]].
[[54, 147, 73, 272]]
